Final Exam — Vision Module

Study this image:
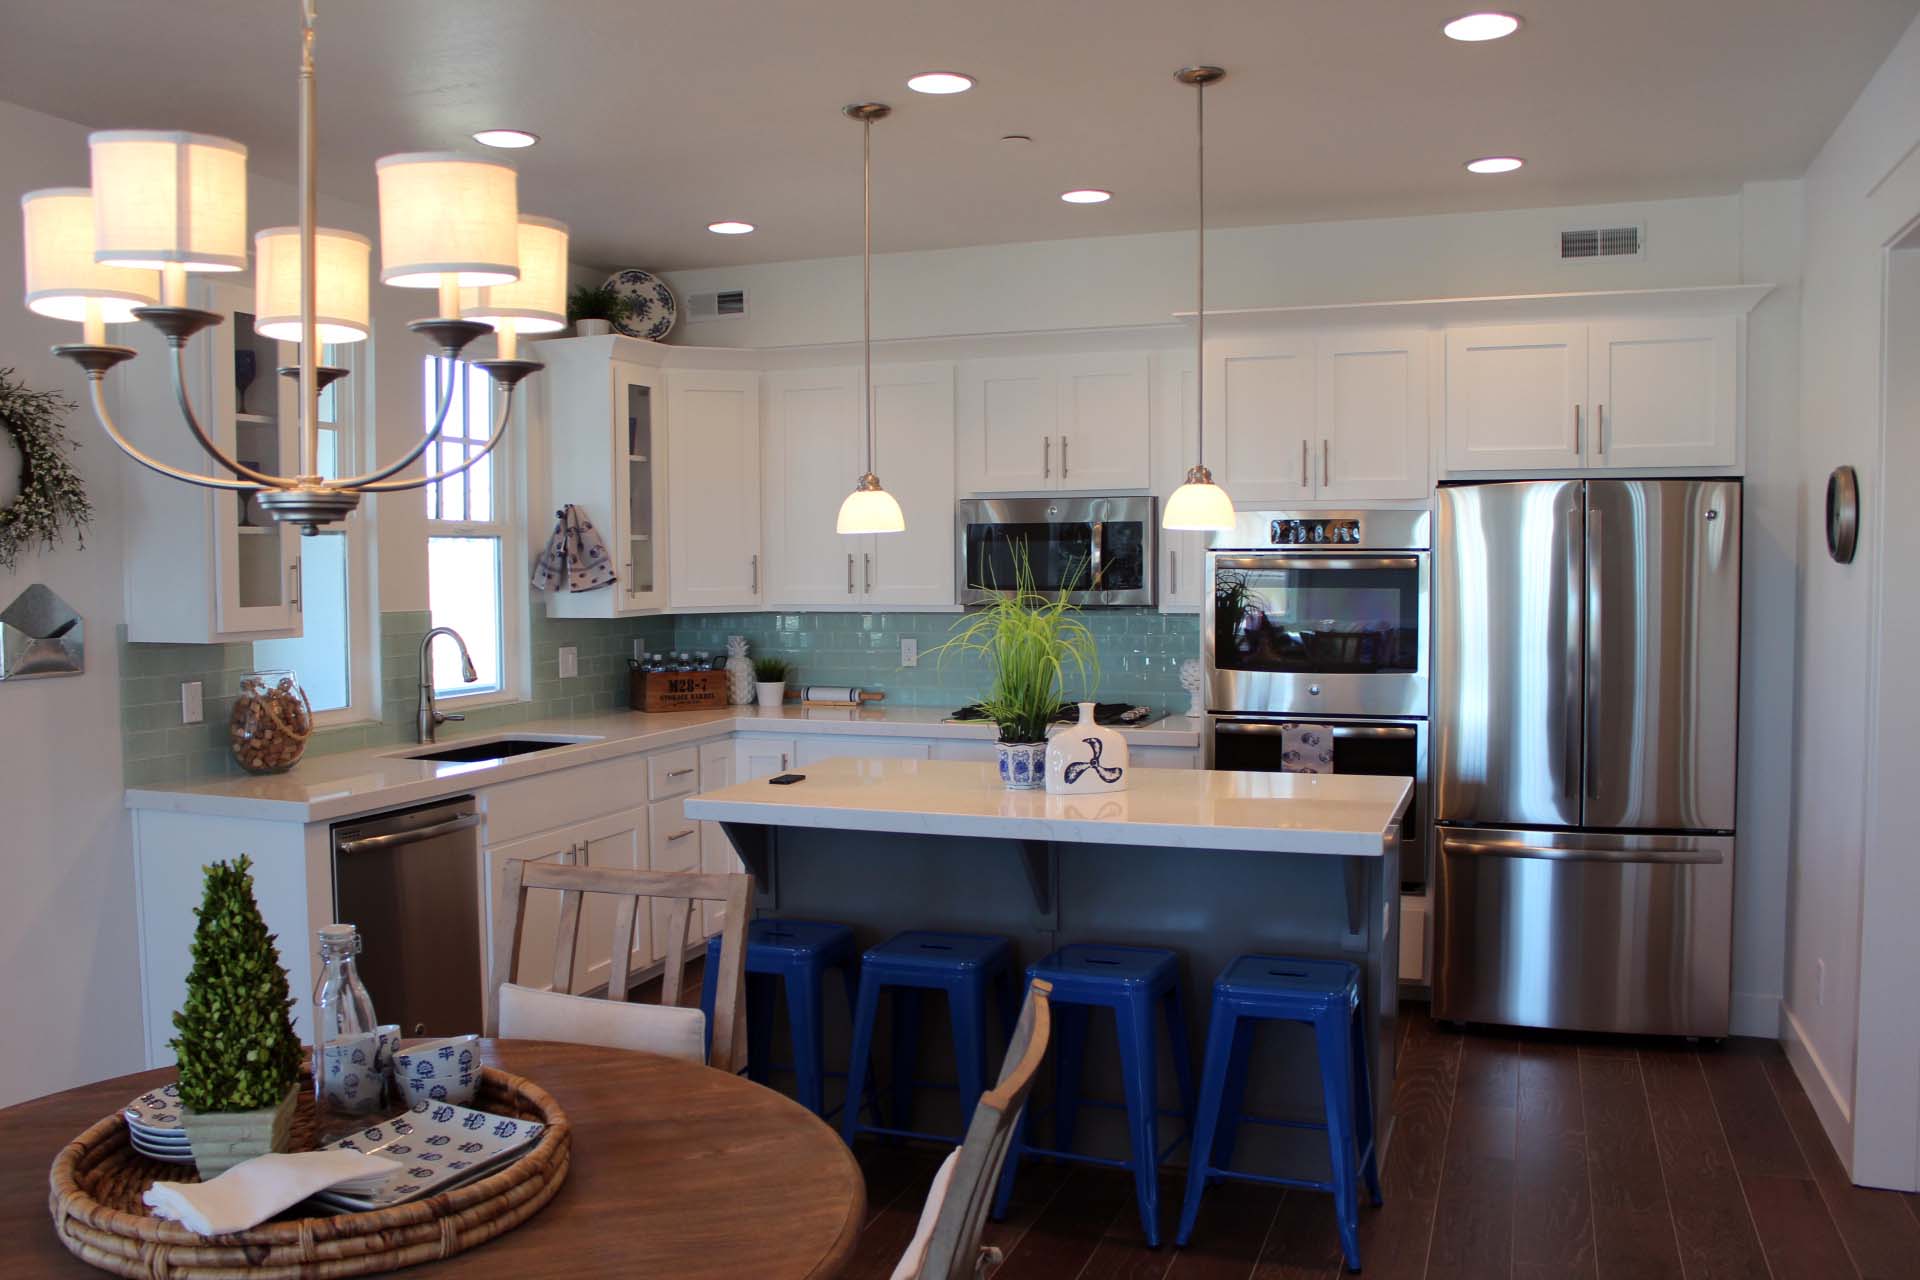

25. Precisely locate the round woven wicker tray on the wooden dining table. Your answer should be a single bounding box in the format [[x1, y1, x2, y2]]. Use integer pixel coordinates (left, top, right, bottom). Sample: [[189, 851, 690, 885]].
[[50, 1067, 572, 1280]]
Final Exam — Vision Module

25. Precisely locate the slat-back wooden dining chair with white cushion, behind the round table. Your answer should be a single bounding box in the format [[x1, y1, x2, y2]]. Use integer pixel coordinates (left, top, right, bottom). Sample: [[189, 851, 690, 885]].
[[488, 858, 753, 1071]]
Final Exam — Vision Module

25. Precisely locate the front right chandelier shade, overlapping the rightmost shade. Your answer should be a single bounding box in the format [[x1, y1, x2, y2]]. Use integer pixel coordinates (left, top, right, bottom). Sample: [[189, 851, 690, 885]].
[[374, 152, 520, 290]]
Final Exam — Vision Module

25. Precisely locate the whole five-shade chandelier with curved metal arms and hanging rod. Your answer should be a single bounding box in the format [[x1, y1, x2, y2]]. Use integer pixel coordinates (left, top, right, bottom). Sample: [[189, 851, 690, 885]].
[[21, 0, 566, 533]]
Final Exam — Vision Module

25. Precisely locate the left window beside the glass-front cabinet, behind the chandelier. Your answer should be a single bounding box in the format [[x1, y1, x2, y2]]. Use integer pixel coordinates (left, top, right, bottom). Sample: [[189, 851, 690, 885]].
[[253, 345, 378, 723]]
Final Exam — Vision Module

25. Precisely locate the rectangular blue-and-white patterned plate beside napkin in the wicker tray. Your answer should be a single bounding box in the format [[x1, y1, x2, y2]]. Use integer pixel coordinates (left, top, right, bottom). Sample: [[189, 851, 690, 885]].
[[313, 1102, 547, 1213]]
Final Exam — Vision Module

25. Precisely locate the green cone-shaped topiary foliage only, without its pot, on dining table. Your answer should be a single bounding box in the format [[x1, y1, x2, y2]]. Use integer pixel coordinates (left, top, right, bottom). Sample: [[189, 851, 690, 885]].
[[169, 854, 301, 1113]]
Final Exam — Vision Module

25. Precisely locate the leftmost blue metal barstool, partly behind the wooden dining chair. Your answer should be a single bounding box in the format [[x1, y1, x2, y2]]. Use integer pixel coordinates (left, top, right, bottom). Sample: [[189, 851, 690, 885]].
[[701, 917, 858, 1117]]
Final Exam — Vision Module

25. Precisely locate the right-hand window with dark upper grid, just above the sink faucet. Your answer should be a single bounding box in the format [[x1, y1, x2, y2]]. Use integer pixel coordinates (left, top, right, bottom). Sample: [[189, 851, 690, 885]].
[[422, 355, 511, 697]]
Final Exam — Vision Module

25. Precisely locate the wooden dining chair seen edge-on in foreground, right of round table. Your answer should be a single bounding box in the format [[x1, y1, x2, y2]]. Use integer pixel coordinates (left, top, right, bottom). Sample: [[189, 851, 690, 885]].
[[893, 979, 1052, 1280]]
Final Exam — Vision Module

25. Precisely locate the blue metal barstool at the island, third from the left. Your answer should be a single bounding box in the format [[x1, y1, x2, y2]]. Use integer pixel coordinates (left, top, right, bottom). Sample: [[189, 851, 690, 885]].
[[993, 942, 1194, 1249]]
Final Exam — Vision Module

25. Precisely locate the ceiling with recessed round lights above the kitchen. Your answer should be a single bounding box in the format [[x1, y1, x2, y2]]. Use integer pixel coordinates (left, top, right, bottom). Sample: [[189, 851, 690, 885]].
[[0, 0, 1920, 269]]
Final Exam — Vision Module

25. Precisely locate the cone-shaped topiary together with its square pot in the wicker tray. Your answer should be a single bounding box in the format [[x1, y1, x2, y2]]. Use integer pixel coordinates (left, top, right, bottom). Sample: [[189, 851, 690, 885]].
[[169, 854, 301, 1178]]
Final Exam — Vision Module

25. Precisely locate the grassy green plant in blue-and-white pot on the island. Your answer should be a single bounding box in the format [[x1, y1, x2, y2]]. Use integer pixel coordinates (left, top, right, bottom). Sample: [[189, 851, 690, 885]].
[[935, 547, 1100, 791]]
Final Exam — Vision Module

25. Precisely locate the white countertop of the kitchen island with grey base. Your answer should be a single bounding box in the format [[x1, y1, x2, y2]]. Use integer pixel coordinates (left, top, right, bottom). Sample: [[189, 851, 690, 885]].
[[685, 758, 1413, 858]]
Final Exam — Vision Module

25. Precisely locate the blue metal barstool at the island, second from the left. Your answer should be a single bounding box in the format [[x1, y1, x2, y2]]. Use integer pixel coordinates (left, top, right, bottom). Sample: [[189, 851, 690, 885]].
[[841, 931, 1020, 1146]]
